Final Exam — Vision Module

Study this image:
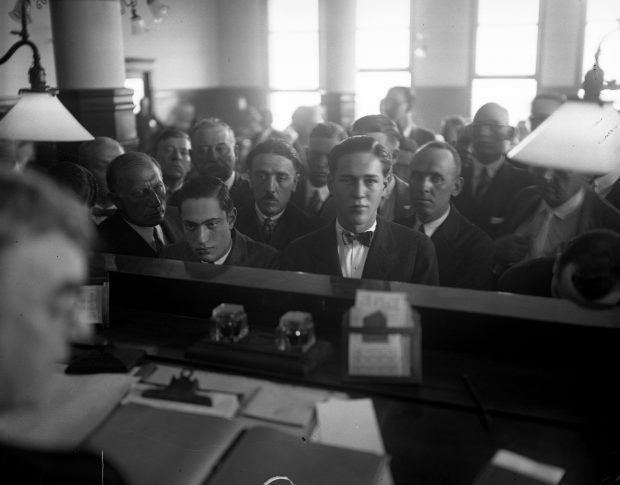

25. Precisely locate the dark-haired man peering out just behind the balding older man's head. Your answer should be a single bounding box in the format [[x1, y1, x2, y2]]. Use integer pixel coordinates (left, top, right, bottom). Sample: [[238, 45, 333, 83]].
[[153, 128, 192, 202]]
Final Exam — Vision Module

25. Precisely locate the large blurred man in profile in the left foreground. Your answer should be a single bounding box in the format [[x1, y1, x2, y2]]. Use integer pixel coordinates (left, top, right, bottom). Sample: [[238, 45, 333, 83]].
[[0, 170, 124, 485]]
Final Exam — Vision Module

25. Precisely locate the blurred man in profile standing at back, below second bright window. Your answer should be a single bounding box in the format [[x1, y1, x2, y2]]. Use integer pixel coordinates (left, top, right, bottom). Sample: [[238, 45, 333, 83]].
[[381, 86, 435, 146]]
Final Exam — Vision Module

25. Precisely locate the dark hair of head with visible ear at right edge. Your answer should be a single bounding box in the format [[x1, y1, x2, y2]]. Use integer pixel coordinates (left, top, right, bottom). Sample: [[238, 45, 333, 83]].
[[557, 229, 620, 300]]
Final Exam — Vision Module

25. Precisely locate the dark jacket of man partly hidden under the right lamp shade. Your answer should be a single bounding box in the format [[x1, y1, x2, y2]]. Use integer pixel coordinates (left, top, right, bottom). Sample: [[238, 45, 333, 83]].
[[500, 187, 620, 235]]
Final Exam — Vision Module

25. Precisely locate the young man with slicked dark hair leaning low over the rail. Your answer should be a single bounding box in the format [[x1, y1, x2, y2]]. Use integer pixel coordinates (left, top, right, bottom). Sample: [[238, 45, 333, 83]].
[[161, 176, 278, 269]]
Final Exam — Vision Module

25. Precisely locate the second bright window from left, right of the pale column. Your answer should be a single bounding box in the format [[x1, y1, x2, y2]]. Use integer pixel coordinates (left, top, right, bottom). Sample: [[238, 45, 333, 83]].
[[355, 0, 411, 118]]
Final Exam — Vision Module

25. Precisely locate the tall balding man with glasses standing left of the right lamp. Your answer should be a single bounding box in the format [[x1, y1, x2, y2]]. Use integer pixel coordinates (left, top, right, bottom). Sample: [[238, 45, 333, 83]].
[[453, 103, 533, 238]]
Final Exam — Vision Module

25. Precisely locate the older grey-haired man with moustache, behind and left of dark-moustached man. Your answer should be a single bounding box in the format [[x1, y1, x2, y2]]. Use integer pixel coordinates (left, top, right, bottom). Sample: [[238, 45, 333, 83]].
[[190, 118, 252, 207]]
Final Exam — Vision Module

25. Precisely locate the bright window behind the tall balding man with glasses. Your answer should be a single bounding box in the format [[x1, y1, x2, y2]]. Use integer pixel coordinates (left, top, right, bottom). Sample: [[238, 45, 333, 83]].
[[471, 0, 539, 125]]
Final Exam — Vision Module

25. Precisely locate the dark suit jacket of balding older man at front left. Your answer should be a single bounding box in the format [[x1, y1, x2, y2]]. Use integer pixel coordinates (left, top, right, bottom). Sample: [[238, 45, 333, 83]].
[[97, 207, 185, 258]]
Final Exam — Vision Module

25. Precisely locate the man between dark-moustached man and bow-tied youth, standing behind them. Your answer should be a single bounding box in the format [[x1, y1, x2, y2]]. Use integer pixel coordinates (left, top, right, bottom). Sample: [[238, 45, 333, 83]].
[[291, 121, 347, 215]]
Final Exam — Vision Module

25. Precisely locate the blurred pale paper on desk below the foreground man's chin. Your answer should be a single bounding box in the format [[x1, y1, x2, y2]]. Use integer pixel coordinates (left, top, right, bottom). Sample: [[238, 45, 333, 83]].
[[0, 372, 137, 447]]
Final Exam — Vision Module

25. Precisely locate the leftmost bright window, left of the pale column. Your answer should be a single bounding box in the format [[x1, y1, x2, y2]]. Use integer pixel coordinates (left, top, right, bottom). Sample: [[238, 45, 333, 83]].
[[268, 0, 321, 130]]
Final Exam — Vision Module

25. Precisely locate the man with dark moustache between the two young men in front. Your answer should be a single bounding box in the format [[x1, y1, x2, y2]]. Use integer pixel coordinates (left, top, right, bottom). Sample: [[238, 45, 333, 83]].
[[237, 139, 322, 250]]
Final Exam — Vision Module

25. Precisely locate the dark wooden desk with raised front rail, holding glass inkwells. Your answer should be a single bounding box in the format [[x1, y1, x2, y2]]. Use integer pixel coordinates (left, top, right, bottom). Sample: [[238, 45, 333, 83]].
[[89, 255, 620, 484]]
